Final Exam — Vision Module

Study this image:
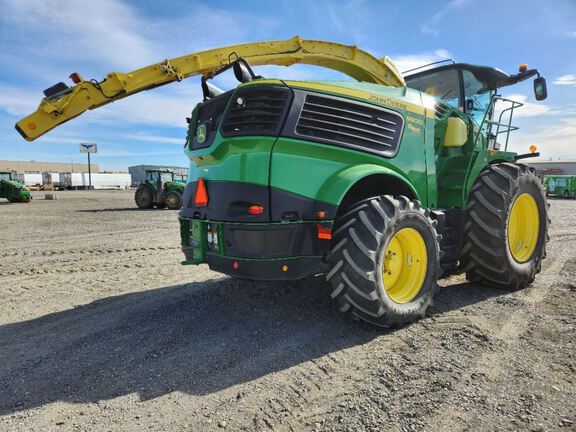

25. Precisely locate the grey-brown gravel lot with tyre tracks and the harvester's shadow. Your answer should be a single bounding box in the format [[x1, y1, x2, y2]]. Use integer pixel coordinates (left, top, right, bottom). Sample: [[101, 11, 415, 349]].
[[0, 191, 576, 431]]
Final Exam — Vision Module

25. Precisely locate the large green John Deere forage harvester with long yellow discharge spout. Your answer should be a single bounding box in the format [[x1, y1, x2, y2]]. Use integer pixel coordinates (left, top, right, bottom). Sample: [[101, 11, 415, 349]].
[[16, 37, 549, 327]]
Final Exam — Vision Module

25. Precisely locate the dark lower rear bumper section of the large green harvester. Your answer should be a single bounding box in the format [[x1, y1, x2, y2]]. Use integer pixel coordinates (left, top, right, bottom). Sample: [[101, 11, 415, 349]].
[[180, 218, 332, 280]]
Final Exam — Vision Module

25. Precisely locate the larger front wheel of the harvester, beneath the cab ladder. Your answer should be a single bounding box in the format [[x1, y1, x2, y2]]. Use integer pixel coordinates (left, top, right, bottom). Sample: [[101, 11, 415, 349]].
[[460, 163, 550, 290]]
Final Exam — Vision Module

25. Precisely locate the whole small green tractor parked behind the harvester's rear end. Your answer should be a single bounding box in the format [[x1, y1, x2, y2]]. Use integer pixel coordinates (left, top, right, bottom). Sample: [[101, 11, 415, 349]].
[[134, 169, 186, 210]]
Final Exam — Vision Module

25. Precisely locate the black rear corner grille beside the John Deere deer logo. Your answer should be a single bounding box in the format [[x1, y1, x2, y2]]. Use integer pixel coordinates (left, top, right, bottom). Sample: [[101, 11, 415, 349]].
[[222, 87, 291, 137]]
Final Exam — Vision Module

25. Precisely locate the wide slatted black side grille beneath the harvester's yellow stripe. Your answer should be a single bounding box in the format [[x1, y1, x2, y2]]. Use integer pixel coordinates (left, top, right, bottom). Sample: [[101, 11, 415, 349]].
[[296, 95, 404, 155]]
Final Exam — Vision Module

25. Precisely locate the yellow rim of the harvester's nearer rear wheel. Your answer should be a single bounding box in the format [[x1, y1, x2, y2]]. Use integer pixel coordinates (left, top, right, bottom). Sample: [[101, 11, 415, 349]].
[[382, 228, 428, 303]]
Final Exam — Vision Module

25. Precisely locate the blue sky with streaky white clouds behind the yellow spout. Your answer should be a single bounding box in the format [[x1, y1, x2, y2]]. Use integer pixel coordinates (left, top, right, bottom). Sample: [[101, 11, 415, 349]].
[[0, 0, 576, 170]]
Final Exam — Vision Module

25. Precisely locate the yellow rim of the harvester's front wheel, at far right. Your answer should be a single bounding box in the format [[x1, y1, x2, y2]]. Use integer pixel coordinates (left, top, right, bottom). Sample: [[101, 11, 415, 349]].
[[507, 193, 540, 263]]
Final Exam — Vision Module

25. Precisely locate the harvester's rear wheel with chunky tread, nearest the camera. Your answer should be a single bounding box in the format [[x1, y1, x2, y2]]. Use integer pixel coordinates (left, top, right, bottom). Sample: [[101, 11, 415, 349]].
[[326, 196, 442, 327]]
